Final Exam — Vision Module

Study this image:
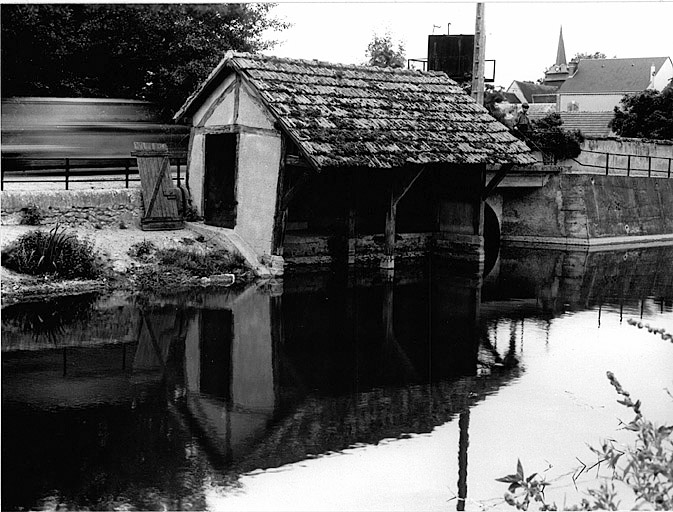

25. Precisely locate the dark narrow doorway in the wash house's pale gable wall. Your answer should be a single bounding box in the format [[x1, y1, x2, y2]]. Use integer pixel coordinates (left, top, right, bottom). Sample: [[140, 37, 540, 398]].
[[203, 133, 238, 228]]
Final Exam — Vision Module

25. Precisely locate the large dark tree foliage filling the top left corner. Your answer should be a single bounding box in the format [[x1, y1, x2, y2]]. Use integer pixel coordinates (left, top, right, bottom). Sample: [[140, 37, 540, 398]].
[[1, 4, 286, 114]]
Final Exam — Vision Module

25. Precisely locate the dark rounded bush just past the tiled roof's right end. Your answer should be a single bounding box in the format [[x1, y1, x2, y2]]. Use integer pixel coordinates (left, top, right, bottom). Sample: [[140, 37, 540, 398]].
[[526, 112, 584, 162]]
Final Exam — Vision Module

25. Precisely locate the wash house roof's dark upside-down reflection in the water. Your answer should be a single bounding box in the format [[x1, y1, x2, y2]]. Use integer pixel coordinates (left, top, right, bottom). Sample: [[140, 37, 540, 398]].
[[231, 366, 522, 472]]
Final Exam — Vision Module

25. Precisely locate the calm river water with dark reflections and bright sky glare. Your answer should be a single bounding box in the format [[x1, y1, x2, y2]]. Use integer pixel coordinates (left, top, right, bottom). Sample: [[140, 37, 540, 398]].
[[2, 247, 673, 510]]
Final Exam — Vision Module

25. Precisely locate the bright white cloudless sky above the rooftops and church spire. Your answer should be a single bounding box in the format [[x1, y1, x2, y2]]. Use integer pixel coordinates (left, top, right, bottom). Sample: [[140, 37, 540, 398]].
[[266, 0, 673, 88]]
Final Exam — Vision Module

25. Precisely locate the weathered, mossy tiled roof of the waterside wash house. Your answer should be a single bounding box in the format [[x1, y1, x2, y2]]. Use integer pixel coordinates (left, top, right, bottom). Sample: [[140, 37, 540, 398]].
[[175, 53, 534, 169]]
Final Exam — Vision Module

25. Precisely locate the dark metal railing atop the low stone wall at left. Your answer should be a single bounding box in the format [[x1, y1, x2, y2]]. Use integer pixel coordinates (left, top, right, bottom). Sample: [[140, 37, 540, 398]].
[[0, 155, 186, 190]]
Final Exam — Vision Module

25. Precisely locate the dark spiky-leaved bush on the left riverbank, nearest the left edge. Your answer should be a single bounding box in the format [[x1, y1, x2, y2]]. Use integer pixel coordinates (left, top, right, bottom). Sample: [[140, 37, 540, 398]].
[[2, 225, 101, 279]]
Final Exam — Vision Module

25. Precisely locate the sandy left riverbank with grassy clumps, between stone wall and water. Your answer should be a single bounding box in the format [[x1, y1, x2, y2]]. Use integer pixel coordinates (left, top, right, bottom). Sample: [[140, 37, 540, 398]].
[[2, 226, 254, 304]]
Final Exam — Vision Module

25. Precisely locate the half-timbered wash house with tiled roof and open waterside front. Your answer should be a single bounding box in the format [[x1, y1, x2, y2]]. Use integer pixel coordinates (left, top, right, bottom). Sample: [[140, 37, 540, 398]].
[[175, 53, 534, 268]]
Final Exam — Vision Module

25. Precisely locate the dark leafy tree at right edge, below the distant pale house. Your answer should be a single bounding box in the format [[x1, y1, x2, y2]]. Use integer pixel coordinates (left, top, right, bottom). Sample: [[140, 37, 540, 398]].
[[610, 81, 673, 140]]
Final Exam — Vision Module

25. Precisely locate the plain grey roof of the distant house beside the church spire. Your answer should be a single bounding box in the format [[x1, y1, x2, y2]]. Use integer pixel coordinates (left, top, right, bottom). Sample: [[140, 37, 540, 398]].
[[558, 57, 668, 94]]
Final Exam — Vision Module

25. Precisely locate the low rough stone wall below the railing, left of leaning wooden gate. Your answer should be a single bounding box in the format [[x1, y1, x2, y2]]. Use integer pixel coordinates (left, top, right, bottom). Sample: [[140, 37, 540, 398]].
[[1, 189, 143, 228]]
